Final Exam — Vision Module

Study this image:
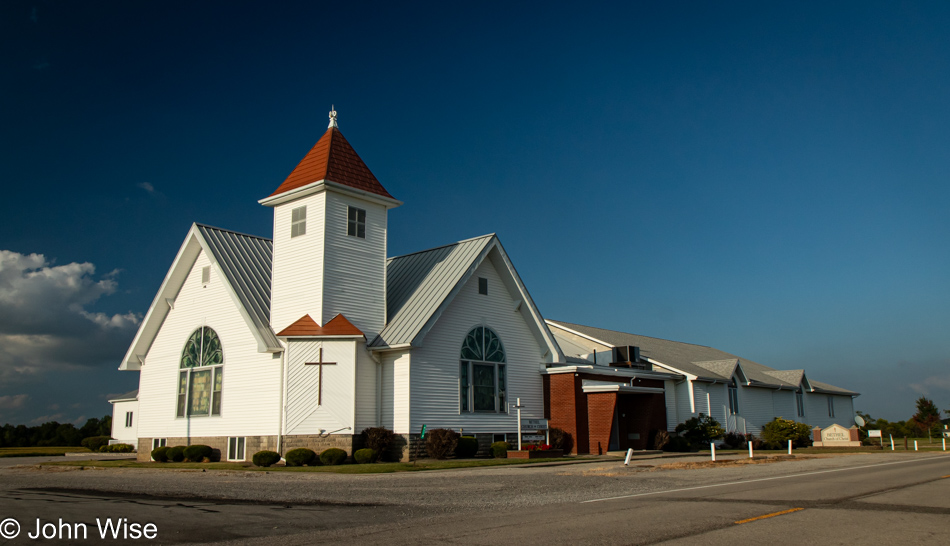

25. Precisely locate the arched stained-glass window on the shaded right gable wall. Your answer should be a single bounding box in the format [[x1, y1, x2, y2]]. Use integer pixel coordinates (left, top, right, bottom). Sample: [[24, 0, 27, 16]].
[[459, 326, 508, 413]]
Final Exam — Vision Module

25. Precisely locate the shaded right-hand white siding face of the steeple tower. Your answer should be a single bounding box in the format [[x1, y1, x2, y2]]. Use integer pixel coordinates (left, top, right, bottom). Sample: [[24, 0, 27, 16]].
[[326, 192, 386, 341]]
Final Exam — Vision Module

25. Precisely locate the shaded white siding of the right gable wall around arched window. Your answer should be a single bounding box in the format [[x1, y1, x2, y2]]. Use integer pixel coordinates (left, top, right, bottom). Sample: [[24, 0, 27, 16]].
[[408, 255, 546, 433]]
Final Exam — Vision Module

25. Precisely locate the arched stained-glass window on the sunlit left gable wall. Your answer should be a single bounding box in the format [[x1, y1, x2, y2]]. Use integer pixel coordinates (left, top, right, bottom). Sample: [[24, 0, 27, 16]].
[[176, 326, 224, 417]]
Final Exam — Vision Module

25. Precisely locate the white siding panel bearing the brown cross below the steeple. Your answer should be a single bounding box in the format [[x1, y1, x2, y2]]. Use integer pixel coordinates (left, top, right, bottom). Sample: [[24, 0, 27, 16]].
[[286, 340, 359, 435]]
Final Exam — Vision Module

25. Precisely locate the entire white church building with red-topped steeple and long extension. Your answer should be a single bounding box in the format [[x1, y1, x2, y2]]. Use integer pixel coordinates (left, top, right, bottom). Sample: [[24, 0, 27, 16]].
[[113, 112, 857, 461]]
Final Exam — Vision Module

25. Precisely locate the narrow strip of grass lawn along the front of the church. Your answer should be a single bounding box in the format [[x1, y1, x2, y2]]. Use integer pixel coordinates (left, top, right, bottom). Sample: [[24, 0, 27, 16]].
[[43, 457, 574, 474]]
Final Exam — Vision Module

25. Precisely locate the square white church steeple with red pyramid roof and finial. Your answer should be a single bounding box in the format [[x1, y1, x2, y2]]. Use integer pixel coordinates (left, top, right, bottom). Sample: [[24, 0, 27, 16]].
[[259, 110, 402, 339]]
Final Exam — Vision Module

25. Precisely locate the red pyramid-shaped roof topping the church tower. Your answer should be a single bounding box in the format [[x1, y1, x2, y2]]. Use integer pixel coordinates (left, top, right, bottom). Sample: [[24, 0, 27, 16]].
[[269, 127, 395, 199]]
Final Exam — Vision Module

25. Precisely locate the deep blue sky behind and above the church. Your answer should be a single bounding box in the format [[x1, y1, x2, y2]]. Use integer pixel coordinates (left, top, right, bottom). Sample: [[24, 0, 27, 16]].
[[0, 1, 950, 423]]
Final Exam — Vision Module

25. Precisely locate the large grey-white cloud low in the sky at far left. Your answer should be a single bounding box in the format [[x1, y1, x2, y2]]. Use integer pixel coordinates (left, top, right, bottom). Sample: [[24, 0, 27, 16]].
[[0, 250, 141, 385]]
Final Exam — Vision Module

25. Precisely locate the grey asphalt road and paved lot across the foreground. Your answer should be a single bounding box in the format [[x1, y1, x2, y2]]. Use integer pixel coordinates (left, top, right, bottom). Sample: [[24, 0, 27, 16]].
[[0, 453, 950, 545]]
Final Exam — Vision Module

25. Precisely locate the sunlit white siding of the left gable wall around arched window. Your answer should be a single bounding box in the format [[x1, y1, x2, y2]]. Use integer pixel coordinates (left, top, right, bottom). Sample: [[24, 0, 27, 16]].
[[138, 252, 280, 438]]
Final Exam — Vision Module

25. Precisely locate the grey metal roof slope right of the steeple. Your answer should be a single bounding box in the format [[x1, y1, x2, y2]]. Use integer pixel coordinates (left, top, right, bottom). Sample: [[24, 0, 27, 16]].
[[370, 234, 495, 347]]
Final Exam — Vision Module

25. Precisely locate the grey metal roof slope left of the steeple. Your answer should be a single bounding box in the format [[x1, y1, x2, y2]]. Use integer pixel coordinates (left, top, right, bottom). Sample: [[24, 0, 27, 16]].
[[195, 224, 281, 347]]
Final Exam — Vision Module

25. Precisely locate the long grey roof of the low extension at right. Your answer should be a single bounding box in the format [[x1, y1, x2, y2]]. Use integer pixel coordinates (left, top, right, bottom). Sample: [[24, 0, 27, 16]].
[[548, 320, 858, 395]]
